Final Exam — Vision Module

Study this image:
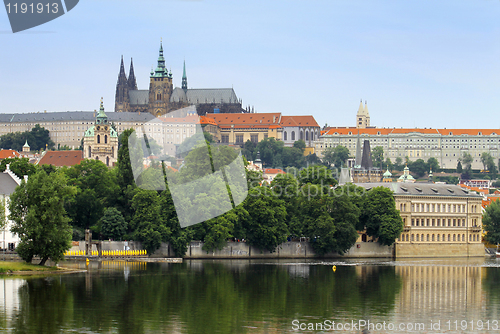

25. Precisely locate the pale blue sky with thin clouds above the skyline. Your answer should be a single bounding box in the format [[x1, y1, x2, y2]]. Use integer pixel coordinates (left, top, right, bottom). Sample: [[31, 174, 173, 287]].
[[0, 0, 500, 129]]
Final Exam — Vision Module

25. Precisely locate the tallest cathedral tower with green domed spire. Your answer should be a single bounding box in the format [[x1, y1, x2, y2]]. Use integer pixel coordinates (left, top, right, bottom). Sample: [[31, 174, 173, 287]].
[[148, 43, 173, 117]]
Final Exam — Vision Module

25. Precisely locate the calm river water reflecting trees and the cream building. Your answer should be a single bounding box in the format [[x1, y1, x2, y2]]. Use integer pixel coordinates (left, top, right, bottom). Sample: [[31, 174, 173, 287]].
[[0, 259, 500, 333]]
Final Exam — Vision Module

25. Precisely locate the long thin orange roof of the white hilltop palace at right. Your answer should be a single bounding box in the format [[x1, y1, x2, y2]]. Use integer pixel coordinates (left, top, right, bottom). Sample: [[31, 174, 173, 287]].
[[322, 127, 500, 136]]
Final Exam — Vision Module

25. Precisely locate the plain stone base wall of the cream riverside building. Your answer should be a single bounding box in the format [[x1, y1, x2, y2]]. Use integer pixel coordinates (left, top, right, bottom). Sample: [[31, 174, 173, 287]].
[[395, 243, 485, 258]]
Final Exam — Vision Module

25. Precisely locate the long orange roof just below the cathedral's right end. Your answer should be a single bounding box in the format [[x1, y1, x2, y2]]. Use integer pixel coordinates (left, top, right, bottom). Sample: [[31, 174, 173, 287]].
[[206, 112, 281, 128]]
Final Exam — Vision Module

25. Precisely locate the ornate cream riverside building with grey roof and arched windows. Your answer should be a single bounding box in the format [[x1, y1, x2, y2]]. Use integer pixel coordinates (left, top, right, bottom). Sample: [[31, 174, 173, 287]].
[[357, 182, 484, 258]]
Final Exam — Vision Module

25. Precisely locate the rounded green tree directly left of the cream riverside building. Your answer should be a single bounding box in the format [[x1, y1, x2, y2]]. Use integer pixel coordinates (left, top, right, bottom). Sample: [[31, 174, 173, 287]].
[[360, 187, 403, 246]]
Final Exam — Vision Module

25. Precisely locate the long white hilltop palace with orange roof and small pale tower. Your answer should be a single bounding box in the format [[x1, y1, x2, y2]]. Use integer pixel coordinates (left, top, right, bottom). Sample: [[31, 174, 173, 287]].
[[314, 101, 500, 169]]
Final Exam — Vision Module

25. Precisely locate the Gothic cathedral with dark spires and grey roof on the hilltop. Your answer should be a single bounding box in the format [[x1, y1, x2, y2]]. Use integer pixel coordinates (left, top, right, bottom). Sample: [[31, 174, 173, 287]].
[[115, 43, 246, 117]]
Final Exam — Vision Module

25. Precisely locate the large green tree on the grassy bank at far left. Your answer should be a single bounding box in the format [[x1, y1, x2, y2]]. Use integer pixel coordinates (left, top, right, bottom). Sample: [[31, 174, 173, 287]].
[[9, 170, 76, 265]]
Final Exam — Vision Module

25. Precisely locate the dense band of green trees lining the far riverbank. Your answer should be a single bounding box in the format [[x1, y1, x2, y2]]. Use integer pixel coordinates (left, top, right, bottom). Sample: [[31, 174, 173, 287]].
[[6, 130, 402, 261]]
